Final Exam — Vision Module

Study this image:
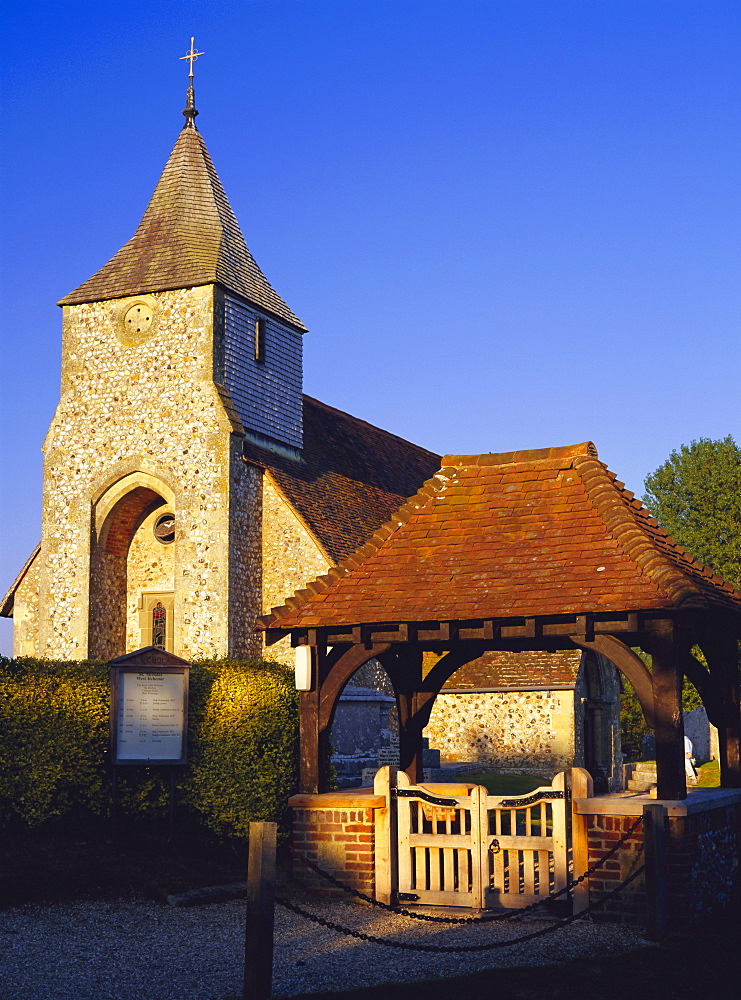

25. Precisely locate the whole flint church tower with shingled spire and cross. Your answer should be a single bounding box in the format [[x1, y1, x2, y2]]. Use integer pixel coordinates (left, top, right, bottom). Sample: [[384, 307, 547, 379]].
[[34, 60, 305, 659]]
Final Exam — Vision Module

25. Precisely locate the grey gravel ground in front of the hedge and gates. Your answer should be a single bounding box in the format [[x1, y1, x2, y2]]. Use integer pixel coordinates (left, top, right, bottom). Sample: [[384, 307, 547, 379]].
[[0, 900, 645, 1000]]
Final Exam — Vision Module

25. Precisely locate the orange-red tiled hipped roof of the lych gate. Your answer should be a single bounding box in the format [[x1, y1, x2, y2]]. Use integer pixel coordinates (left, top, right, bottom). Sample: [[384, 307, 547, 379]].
[[262, 443, 741, 629]]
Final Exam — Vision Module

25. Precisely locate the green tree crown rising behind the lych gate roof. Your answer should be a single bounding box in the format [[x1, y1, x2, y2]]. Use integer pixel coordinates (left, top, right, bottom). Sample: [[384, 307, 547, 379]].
[[643, 435, 741, 589]]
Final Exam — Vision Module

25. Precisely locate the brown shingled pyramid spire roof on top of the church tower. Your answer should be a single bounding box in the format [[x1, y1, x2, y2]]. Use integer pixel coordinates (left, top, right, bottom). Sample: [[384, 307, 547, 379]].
[[54, 128, 306, 330]]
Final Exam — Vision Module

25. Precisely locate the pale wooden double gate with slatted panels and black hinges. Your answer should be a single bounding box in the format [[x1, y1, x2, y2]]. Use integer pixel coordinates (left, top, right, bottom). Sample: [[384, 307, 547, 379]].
[[390, 771, 569, 909]]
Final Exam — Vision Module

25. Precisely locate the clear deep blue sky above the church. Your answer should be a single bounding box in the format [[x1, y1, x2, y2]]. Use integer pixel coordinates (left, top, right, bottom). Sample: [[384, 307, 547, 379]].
[[0, 0, 741, 652]]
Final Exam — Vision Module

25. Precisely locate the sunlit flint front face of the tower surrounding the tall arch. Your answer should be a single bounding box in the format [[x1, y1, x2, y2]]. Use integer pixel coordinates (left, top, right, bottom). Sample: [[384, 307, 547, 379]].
[[38, 286, 243, 658]]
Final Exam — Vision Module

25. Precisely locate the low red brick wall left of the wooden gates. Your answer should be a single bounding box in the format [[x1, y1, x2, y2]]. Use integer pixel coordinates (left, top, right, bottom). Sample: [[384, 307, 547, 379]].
[[288, 791, 386, 898]]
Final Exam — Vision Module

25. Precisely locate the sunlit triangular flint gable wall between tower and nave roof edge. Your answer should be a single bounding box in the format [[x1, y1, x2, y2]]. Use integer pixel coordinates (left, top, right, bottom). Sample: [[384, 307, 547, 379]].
[[262, 475, 332, 663]]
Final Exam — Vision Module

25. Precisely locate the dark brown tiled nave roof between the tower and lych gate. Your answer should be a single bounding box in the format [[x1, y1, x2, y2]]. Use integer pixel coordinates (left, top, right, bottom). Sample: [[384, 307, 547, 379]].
[[245, 396, 440, 562]]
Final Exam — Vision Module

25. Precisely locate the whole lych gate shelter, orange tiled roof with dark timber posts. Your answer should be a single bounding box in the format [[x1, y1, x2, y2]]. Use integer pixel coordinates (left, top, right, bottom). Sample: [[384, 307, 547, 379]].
[[262, 443, 741, 799]]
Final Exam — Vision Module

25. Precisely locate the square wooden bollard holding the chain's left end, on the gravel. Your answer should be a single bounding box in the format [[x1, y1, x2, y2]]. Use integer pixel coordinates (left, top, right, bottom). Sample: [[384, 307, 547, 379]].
[[243, 823, 278, 1000]]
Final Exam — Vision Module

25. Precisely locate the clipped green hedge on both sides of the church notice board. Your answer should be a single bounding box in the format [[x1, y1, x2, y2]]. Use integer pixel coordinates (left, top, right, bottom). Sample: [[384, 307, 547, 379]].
[[0, 658, 298, 837]]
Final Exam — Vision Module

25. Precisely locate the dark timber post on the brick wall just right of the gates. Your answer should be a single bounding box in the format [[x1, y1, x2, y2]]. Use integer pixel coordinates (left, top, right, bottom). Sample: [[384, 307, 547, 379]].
[[651, 628, 687, 799]]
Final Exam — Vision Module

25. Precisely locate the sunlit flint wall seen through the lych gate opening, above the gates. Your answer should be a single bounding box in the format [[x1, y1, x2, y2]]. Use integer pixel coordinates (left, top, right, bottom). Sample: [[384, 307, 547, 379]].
[[425, 690, 574, 777]]
